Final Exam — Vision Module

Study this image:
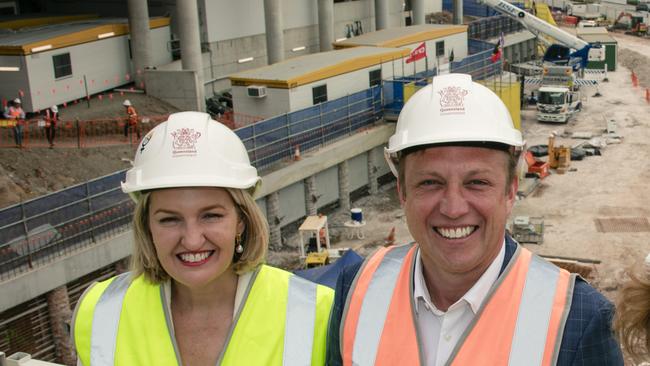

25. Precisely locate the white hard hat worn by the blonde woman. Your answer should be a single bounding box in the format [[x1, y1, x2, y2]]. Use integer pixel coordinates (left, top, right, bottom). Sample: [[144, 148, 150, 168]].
[[122, 112, 260, 198]]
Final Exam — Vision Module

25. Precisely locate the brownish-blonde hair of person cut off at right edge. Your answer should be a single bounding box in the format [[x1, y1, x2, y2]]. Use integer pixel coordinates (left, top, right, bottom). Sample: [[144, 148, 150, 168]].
[[613, 264, 650, 363]]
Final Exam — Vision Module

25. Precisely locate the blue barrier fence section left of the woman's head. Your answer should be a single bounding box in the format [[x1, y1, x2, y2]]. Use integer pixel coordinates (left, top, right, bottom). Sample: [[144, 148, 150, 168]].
[[0, 171, 133, 281]]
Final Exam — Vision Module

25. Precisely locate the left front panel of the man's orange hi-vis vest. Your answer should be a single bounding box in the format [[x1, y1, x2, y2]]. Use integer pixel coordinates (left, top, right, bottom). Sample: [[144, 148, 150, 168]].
[[340, 245, 421, 365]]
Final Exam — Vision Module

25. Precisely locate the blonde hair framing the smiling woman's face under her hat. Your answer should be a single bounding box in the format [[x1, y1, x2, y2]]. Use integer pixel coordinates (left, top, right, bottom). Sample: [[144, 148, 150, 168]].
[[131, 188, 269, 283]]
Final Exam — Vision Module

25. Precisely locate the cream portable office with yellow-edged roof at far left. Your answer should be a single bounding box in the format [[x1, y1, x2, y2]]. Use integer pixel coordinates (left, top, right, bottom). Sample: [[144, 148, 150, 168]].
[[0, 17, 172, 112]]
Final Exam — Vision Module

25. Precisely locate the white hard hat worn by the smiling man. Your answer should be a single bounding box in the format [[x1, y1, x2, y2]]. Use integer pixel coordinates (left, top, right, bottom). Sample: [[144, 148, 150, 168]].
[[384, 74, 524, 176]]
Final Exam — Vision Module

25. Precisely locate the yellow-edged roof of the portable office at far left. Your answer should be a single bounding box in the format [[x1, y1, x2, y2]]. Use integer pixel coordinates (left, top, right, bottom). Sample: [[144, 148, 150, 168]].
[[0, 17, 169, 55]]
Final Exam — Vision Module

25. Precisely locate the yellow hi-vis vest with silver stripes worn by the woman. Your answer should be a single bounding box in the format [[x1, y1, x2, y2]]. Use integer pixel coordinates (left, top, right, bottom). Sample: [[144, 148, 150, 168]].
[[73, 266, 334, 366]]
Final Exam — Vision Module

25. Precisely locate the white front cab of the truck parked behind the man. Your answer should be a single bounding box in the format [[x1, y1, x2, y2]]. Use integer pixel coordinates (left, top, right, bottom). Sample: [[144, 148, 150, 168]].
[[537, 86, 582, 123]]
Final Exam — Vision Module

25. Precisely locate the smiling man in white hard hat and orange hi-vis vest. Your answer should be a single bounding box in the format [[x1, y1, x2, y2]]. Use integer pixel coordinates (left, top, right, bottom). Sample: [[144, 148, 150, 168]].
[[328, 74, 623, 366]]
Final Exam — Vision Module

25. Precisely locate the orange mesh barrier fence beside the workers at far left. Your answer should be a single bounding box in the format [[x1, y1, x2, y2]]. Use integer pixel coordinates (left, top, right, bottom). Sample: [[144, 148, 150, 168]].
[[0, 115, 168, 148]]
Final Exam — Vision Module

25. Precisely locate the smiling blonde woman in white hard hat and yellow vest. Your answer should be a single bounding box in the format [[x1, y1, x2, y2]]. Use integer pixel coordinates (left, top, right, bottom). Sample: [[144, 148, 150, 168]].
[[73, 112, 333, 366]]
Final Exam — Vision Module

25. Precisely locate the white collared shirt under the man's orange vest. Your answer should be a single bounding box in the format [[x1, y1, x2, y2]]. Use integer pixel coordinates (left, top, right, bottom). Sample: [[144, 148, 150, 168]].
[[413, 240, 506, 366]]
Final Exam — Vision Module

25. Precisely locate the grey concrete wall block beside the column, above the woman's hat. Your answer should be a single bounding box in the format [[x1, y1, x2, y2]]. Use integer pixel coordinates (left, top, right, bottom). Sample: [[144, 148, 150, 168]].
[[144, 70, 200, 111]]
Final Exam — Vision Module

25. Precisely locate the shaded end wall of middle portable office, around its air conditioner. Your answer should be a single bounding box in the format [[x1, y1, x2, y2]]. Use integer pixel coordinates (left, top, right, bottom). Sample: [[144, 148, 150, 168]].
[[231, 86, 291, 119]]
